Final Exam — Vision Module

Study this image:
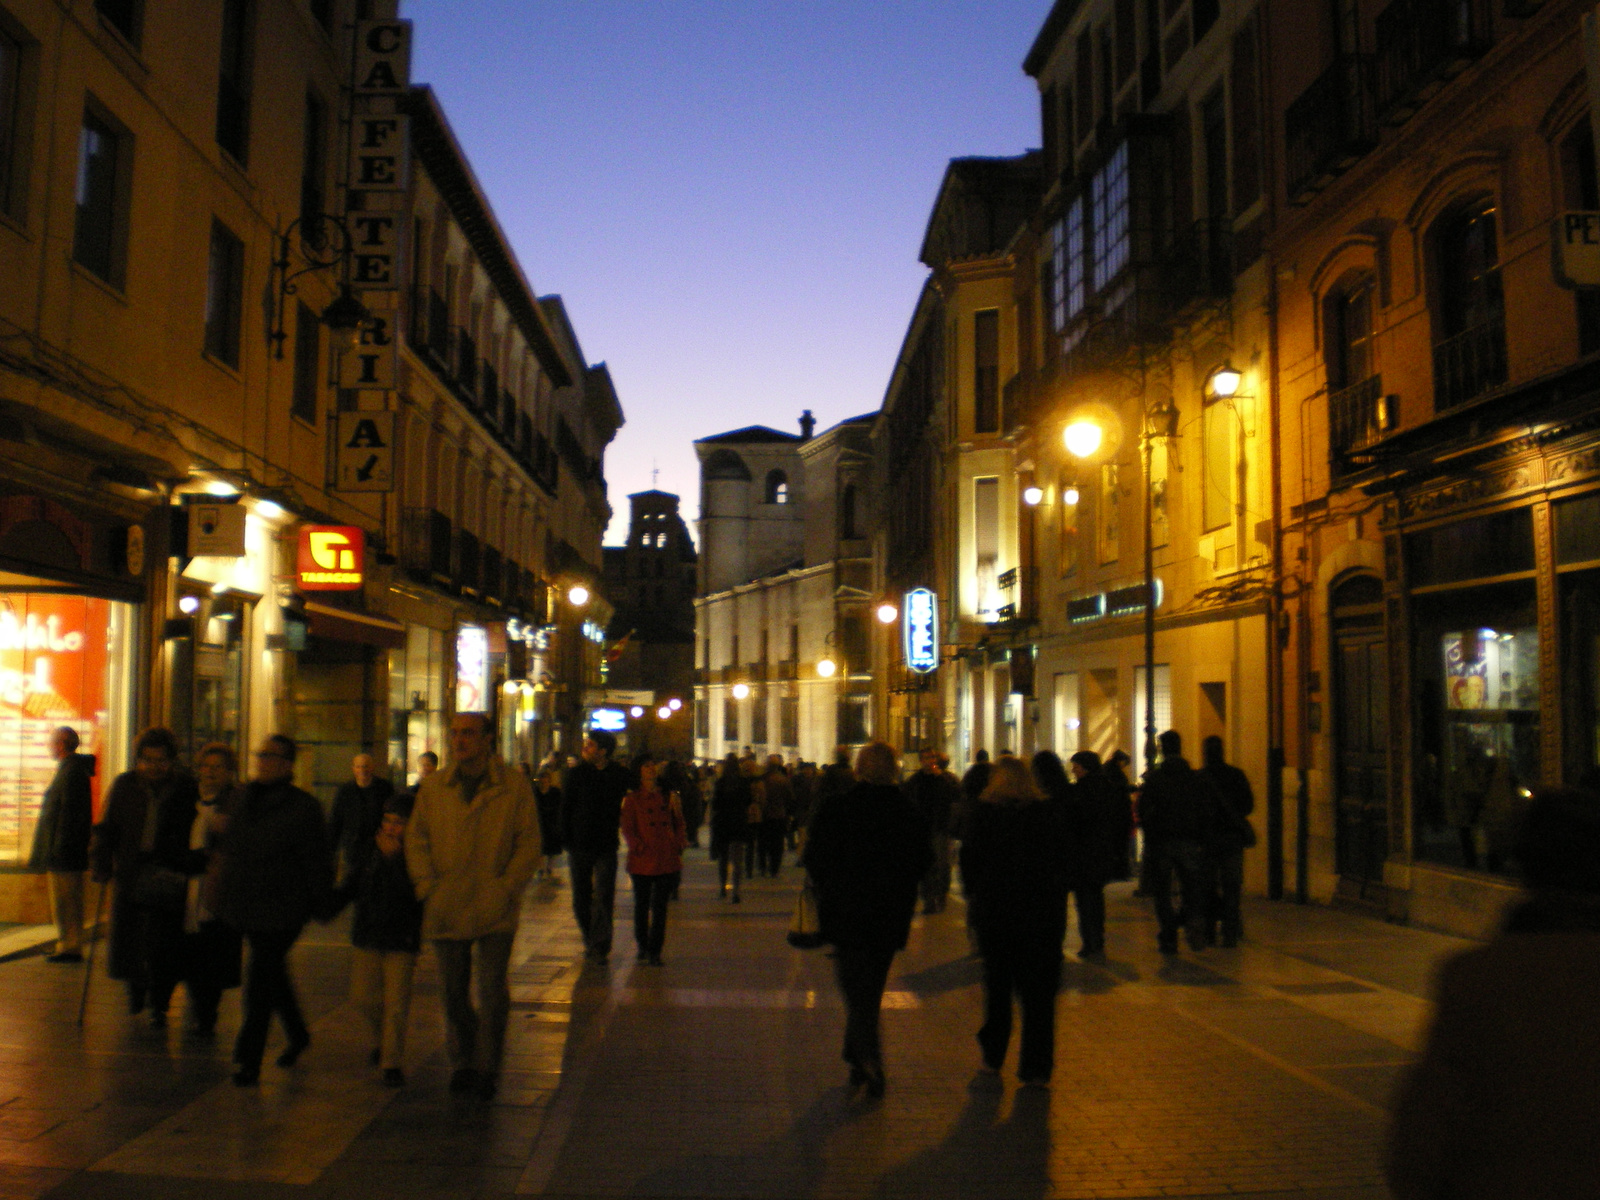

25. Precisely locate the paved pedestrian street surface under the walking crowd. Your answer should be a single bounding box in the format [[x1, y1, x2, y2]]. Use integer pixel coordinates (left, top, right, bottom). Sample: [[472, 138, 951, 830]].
[[0, 851, 1466, 1200]]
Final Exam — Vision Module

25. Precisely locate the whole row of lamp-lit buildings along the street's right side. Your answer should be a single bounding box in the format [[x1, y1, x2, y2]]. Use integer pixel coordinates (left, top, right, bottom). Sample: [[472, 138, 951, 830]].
[[696, 0, 1600, 934]]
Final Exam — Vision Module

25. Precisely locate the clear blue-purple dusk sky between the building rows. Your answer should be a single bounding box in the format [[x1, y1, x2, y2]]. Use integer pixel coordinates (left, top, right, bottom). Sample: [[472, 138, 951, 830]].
[[402, 0, 1050, 542]]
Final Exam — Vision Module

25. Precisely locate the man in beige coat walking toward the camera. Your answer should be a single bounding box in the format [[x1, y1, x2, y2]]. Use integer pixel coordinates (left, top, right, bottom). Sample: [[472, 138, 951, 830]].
[[405, 712, 542, 1099]]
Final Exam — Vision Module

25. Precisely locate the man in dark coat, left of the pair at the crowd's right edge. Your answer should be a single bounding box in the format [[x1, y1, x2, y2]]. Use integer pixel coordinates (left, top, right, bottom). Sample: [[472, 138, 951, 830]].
[[1139, 730, 1216, 954]]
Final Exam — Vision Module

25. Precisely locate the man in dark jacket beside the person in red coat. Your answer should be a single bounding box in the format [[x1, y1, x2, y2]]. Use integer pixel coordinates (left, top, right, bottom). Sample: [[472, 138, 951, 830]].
[[562, 730, 632, 963]]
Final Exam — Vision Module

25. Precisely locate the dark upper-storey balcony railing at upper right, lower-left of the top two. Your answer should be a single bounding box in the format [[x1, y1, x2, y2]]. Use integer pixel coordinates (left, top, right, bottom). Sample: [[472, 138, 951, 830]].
[[1283, 54, 1378, 205]]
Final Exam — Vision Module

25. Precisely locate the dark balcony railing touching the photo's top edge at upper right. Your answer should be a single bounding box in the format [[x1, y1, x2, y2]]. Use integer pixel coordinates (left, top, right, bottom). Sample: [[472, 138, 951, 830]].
[[1374, 0, 1490, 125]]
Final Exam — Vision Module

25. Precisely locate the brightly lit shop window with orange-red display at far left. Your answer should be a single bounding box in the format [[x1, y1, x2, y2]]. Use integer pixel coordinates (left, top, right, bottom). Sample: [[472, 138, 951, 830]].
[[0, 592, 130, 866]]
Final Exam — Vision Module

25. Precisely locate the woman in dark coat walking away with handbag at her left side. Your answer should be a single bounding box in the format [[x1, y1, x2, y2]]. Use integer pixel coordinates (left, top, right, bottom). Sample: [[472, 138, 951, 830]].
[[802, 742, 933, 1098]]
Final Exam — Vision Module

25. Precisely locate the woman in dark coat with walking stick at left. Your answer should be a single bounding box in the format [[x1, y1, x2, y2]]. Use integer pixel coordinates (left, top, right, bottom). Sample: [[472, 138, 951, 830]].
[[90, 728, 205, 1029]]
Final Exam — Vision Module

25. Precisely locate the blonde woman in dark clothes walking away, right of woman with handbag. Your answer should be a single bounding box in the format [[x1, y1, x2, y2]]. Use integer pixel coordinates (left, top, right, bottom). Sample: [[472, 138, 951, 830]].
[[962, 755, 1067, 1086]]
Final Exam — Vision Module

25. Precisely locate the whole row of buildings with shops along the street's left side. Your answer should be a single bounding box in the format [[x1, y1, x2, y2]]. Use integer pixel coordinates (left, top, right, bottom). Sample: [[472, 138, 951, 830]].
[[0, 0, 622, 920]]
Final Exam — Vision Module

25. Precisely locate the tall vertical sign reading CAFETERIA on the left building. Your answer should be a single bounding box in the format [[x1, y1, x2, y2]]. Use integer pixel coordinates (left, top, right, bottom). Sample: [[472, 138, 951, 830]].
[[339, 19, 411, 392]]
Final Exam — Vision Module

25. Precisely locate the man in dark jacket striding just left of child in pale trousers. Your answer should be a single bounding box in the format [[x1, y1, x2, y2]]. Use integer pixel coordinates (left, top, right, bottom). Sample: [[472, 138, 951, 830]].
[[216, 733, 331, 1088]]
